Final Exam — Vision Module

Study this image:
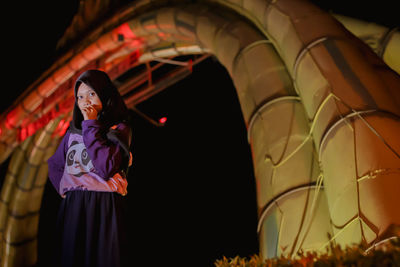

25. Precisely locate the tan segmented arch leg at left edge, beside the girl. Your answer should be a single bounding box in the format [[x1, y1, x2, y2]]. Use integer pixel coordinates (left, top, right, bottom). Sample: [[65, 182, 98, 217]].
[[0, 119, 66, 266]]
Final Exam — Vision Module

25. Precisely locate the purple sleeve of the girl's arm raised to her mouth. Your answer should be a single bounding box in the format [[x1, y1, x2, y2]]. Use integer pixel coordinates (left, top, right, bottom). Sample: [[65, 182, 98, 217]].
[[82, 120, 130, 180]]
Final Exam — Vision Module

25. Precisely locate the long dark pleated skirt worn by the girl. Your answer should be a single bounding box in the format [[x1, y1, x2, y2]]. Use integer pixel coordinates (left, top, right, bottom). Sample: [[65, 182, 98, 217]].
[[54, 191, 128, 267]]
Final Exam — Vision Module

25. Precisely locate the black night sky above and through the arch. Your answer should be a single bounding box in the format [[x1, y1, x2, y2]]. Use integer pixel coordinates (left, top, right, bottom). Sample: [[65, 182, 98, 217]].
[[0, 0, 399, 266]]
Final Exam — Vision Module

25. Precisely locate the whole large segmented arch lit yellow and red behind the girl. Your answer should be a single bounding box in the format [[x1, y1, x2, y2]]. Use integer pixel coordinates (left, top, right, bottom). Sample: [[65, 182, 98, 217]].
[[0, 0, 400, 266]]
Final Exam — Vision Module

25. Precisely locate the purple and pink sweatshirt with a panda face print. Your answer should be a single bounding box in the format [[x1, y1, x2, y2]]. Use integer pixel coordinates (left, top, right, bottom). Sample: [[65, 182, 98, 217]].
[[47, 120, 132, 197]]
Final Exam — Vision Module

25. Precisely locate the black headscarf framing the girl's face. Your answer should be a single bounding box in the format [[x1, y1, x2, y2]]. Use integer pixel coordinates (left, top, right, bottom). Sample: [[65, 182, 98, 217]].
[[71, 69, 130, 131]]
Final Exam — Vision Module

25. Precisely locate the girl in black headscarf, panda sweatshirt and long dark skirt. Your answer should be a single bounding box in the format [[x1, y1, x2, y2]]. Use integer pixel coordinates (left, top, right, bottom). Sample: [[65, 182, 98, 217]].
[[48, 70, 132, 267]]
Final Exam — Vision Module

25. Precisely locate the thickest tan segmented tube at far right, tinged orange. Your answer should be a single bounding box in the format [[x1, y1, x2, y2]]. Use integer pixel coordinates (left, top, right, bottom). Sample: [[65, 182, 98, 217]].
[[227, 0, 400, 251]]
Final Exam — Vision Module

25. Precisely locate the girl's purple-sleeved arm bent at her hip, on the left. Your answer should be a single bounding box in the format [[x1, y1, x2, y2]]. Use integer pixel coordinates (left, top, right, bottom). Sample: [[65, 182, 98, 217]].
[[47, 131, 69, 193]]
